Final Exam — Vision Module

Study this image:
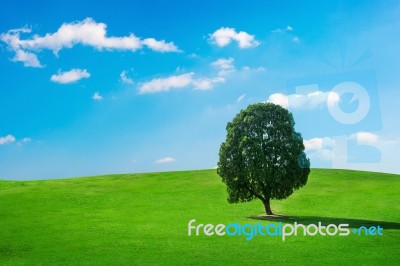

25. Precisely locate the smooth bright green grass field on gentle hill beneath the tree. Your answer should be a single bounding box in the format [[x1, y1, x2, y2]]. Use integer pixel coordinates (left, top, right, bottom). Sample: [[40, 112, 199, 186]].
[[0, 169, 400, 265]]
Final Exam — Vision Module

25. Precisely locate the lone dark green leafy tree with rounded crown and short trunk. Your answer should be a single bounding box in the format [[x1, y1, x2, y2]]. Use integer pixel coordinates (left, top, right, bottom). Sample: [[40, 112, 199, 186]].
[[217, 103, 310, 215]]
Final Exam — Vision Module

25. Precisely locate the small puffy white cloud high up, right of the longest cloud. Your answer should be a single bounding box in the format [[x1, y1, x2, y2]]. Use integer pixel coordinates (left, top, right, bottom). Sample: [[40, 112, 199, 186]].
[[210, 27, 260, 49]]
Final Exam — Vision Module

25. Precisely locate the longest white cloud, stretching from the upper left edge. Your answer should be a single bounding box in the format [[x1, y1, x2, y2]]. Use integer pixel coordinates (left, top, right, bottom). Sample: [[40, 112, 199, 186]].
[[0, 18, 180, 67]]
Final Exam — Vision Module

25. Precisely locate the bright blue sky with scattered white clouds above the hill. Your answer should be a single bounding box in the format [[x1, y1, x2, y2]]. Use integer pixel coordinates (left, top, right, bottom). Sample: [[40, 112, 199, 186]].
[[0, 1, 400, 179]]
